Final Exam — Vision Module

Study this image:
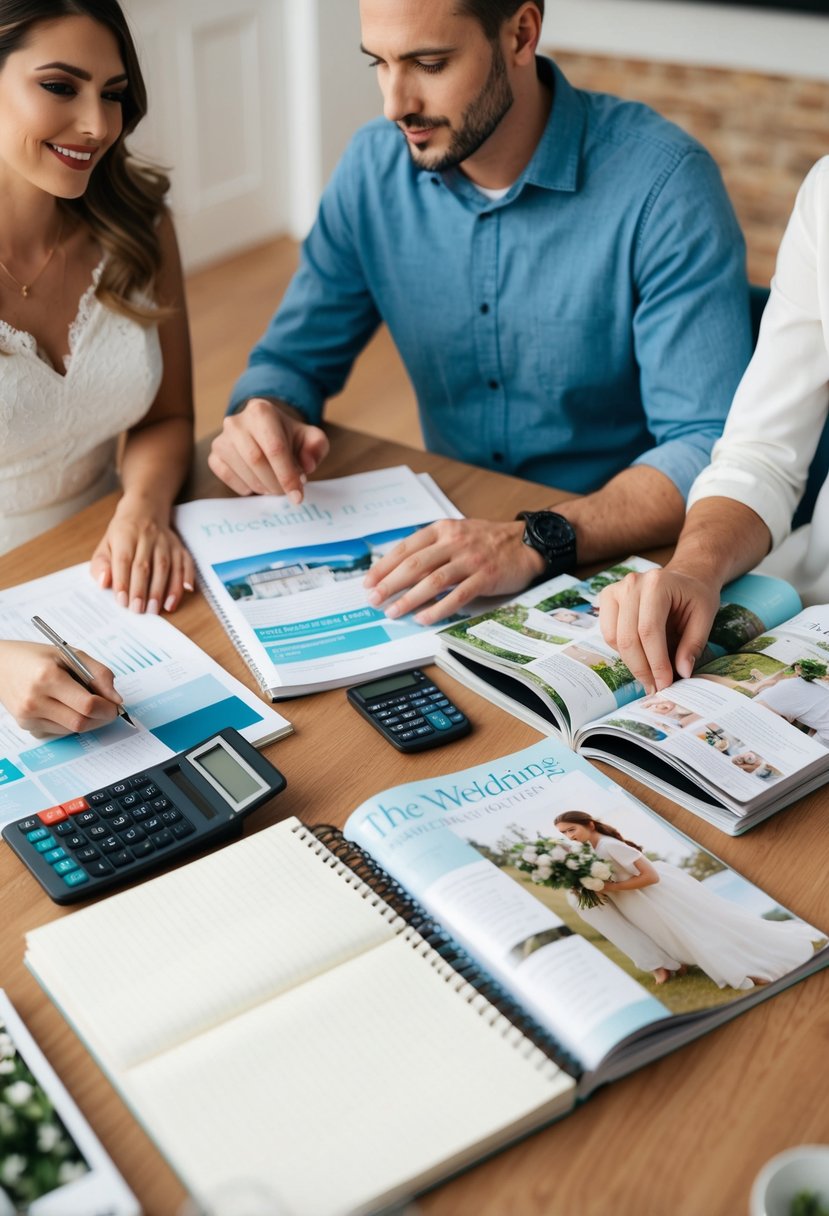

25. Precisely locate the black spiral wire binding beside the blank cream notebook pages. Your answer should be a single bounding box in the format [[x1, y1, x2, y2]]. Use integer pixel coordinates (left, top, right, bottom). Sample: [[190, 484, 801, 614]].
[[295, 823, 583, 1080]]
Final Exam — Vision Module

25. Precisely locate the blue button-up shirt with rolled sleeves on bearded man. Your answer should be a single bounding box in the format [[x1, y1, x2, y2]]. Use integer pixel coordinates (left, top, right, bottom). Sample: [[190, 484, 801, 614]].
[[231, 60, 751, 495]]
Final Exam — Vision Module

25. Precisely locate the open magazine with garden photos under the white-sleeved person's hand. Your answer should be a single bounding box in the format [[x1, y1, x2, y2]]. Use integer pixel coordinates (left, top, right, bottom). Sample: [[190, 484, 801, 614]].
[[438, 558, 829, 835]]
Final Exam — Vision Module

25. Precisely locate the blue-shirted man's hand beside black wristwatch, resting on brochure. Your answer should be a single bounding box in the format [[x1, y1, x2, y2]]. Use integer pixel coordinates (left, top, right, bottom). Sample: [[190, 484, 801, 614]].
[[363, 519, 543, 625]]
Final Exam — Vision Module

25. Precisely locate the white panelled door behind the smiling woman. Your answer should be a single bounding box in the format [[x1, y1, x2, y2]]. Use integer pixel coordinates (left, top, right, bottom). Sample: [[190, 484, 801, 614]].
[[124, 0, 287, 269]]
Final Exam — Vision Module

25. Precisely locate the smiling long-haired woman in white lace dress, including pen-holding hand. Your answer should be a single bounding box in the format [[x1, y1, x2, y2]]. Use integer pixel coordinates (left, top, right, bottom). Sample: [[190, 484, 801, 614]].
[[0, 0, 193, 736]]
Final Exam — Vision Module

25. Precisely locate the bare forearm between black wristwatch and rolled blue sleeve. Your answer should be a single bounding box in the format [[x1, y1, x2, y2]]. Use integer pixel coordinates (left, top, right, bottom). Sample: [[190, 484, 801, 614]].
[[553, 465, 686, 563]]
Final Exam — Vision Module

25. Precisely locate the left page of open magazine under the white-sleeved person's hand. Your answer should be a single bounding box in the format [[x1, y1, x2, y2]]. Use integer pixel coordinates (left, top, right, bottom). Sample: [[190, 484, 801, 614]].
[[438, 557, 800, 738]]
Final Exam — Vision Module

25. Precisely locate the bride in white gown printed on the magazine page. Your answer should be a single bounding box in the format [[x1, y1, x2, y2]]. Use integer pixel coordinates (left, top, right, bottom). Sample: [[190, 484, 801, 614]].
[[556, 811, 820, 989]]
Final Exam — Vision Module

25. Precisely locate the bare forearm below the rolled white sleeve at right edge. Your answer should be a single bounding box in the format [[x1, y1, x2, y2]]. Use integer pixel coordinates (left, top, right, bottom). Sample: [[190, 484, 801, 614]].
[[667, 497, 772, 590]]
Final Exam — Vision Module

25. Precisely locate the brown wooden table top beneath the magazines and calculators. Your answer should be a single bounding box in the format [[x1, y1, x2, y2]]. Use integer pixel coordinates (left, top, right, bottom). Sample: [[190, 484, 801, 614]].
[[0, 427, 829, 1216]]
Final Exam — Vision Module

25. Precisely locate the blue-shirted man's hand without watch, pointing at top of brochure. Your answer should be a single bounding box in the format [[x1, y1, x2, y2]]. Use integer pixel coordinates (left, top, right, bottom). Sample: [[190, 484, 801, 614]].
[[208, 396, 328, 505]]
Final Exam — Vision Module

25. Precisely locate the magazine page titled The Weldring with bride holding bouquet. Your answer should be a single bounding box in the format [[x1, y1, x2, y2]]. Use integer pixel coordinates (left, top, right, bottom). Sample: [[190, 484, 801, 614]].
[[345, 739, 823, 1070]]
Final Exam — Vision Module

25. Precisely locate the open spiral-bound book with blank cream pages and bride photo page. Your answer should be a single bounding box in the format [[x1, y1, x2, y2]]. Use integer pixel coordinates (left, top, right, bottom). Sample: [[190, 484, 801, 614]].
[[26, 738, 829, 1216]]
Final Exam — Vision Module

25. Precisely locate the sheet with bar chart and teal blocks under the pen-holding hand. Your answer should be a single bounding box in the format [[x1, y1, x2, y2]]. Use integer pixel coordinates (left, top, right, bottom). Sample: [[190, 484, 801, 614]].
[[0, 563, 292, 826]]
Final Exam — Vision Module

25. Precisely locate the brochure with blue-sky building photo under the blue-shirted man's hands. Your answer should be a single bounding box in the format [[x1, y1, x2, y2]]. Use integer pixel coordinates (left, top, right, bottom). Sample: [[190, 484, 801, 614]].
[[175, 466, 459, 696]]
